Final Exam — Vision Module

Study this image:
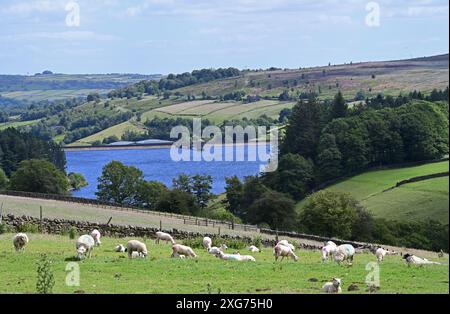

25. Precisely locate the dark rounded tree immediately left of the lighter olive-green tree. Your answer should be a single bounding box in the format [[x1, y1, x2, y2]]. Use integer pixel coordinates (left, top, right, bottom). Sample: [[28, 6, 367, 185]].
[[246, 190, 296, 230]]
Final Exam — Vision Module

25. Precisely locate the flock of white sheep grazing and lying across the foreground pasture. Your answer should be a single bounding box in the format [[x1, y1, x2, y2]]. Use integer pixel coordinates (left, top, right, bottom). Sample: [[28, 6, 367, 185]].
[[9, 230, 440, 293]]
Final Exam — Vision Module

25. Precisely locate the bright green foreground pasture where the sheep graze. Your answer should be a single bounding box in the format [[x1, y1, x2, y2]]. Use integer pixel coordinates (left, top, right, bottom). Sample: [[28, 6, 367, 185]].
[[0, 234, 449, 294]]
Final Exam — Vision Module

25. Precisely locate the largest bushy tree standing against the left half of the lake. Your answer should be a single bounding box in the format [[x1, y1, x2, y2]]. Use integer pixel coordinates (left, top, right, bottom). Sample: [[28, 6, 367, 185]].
[[96, 161, 144, 205]]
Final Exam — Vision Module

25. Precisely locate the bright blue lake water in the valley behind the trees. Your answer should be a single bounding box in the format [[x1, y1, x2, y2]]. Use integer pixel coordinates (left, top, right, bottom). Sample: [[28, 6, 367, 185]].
[[66, 145, 269, 198]]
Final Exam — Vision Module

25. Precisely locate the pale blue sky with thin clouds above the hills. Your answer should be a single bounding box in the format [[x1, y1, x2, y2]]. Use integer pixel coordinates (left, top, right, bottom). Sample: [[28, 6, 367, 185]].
[[0, 0, 449, 75]]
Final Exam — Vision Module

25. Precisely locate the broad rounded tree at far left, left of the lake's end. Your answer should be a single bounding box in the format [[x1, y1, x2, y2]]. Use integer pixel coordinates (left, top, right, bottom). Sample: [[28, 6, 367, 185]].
[[10, 159, 68, 195]]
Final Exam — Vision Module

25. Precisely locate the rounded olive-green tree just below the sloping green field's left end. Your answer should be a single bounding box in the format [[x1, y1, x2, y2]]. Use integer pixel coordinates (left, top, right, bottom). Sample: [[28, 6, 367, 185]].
[[299, 191, 362, 240]]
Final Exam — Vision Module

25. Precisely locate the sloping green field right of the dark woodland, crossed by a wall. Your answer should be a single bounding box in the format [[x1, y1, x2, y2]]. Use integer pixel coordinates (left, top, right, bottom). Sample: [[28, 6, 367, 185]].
[[299, 161, 449, 223]]
